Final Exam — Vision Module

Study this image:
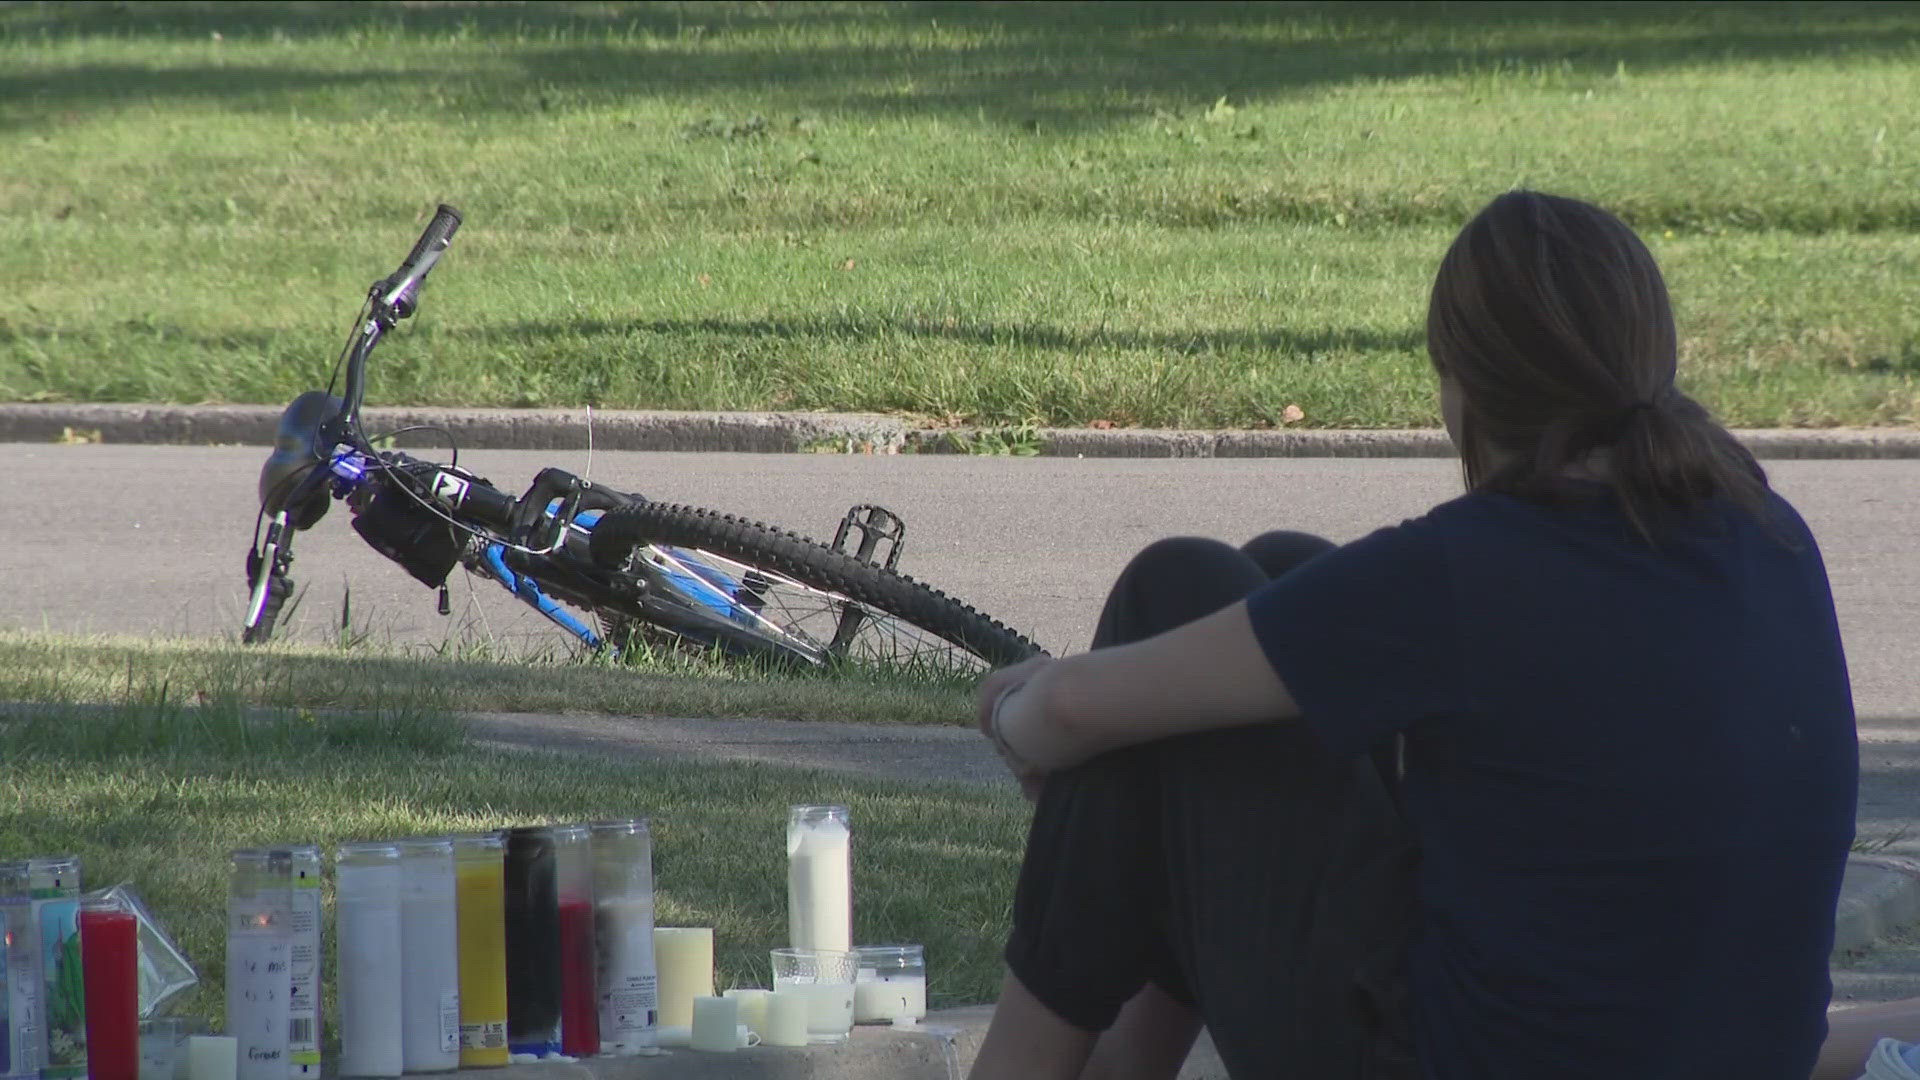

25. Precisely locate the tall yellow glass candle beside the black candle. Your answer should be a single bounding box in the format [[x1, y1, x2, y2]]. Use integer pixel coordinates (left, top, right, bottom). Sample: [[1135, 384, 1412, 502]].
[[453, 832, 511, 1068]]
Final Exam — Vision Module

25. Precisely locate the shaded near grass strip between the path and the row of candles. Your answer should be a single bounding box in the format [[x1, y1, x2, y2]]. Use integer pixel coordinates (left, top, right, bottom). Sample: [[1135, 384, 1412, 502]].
[[0, 684, 1027, 1019]]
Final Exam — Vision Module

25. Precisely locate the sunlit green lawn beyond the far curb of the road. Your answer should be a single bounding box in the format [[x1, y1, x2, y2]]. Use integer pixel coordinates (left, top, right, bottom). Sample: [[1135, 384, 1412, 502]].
[[0, 2, 1920, 427]]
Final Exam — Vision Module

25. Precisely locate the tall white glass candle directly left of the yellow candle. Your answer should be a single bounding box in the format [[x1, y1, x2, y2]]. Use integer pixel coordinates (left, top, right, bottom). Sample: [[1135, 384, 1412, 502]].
[[397, 836, 461, 1072]]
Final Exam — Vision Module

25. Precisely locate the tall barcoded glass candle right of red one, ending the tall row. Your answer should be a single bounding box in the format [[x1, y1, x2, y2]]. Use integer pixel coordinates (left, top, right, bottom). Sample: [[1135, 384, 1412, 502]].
[[593, 819, 660, 1051]]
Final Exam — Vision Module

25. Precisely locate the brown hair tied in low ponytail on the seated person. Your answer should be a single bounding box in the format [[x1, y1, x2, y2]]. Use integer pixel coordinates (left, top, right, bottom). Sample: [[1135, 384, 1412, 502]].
[[1427, 190, 1766, 542]]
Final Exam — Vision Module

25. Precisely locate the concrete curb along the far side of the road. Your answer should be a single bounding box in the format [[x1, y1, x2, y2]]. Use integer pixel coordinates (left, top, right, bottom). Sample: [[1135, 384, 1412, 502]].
[[0, 404, 1920, 459]]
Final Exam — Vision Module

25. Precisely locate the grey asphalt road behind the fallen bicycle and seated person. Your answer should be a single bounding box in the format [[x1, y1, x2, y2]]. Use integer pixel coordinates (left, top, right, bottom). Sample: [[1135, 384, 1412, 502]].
[[0, 444, 1920, 711]]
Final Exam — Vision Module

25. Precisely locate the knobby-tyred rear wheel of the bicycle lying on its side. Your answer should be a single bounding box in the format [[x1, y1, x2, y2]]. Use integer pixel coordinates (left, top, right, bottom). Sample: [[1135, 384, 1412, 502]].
[[589, 502, 1043, 676]]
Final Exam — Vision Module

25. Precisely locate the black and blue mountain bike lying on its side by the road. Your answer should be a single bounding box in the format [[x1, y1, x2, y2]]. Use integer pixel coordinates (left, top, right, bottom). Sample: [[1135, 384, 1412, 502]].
[[240, 204, 1041, 675]]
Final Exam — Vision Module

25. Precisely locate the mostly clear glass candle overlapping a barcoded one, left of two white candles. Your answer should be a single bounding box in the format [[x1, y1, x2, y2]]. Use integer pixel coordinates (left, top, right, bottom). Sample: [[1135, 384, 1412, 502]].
[[227, 849, 294, 1080]]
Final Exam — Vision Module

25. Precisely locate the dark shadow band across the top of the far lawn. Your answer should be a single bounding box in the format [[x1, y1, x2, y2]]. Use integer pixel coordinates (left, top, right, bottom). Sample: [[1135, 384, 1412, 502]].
[[0, 2, 1920, 129]]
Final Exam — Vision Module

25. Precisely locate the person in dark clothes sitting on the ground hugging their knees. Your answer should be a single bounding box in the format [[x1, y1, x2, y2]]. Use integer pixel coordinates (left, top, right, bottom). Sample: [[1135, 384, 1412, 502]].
[[972, 190, 1868, 1080]]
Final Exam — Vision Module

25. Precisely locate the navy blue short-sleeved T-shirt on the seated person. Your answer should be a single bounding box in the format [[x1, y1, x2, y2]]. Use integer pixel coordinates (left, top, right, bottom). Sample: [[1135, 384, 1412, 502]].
[[1248, 486, 1859, 1080]]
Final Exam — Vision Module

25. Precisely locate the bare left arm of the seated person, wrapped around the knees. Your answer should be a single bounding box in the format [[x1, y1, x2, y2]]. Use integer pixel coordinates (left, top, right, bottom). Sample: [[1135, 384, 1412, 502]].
[[981, 603, 1300, 773]]
